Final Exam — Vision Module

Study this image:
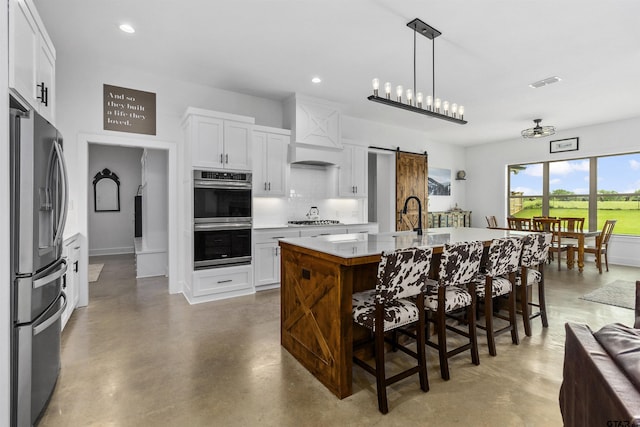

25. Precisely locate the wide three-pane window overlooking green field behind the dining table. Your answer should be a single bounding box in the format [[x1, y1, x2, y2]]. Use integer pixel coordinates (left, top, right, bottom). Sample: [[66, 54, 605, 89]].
[[508, 153, 640, 236]]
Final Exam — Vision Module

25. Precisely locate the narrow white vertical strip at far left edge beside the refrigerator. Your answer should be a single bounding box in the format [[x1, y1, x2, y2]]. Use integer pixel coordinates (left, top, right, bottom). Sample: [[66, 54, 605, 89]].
[[0, 1, 11, 426]]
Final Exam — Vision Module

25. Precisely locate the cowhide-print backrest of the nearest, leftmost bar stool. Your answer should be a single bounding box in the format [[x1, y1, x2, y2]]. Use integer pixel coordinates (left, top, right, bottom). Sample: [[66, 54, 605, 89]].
[[375, 248, 433, 304]]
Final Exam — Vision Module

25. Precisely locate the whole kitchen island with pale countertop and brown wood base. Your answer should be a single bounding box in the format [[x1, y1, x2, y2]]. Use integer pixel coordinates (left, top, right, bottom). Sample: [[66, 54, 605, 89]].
[[280, 228, 528, 399]]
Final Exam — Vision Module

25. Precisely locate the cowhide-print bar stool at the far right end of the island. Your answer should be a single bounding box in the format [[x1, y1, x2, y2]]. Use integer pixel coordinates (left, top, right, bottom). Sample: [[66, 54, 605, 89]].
[[516, 233, 553, 337]]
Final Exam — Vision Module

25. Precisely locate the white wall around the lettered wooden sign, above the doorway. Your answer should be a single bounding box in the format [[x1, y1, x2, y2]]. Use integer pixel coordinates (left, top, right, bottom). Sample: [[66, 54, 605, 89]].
[[56, 55, 282, 239]]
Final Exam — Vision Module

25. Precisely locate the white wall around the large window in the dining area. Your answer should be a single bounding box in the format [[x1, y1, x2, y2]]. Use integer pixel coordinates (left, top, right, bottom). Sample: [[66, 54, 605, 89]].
[[462, 118, 640, 266]]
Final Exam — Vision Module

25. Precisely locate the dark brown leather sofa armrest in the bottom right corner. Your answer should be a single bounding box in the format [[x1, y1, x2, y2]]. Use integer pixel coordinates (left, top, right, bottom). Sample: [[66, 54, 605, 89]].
[[560, 323, 640, 427]]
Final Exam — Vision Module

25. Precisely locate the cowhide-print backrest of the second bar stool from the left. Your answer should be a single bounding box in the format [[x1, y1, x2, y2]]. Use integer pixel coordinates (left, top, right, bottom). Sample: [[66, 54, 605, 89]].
[[438, 242, 484, 286]]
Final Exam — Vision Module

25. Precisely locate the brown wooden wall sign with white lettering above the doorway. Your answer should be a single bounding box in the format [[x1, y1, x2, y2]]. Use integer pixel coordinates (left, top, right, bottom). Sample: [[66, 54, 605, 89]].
[[103, 85, 156, 135]]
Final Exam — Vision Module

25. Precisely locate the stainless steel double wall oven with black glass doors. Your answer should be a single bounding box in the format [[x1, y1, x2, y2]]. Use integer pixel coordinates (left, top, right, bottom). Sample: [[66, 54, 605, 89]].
[[193, 170, 252, 269]]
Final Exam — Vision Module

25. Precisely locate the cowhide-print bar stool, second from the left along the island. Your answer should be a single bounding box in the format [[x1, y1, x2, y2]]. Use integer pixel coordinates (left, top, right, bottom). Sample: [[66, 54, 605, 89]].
[[425, 242, 483, 380]]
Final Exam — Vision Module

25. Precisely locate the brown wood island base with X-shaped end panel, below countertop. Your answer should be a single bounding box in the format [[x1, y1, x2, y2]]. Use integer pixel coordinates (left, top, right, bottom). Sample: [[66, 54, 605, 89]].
[[280, 242, 380, 399]]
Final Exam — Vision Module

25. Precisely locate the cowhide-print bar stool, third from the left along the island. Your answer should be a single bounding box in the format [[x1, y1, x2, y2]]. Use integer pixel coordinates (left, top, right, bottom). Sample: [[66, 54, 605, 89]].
[[476, 237, 522, 356]]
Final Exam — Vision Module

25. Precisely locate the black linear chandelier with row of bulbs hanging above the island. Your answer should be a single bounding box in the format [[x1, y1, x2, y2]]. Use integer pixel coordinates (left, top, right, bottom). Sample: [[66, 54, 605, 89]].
[[367, 18, 467, 125]]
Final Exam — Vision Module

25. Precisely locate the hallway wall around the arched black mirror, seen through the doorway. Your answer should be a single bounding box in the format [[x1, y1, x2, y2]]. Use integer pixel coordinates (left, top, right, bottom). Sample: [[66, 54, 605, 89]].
[[87, 144, 142, 256]]
